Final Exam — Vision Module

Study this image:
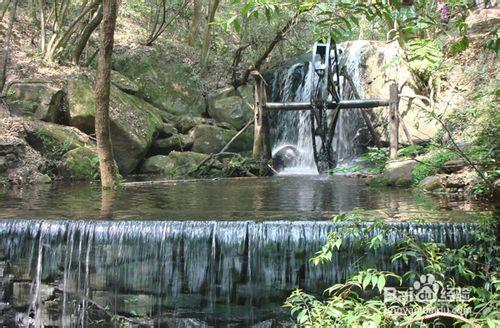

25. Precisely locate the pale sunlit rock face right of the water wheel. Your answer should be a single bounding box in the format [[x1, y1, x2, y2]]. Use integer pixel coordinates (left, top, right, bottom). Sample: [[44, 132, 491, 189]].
[[340, 40, 439, 143]]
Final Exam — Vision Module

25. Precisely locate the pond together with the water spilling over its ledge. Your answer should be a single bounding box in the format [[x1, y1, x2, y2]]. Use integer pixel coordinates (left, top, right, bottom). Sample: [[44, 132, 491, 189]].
[[0, 176, 484, 327]]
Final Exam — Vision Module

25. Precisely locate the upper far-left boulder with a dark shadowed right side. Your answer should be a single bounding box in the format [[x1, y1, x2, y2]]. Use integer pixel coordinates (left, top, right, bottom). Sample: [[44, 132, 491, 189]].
[[7, 81, 67, 123]]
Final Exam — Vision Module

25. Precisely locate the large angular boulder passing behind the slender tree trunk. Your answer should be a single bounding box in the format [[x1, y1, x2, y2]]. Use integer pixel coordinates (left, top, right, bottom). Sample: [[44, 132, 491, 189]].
[[68, 77, 163, 174]]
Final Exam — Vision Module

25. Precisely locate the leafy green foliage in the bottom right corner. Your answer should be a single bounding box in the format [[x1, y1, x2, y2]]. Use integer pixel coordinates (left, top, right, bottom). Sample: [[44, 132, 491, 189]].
[[284, 215, 500, 327]]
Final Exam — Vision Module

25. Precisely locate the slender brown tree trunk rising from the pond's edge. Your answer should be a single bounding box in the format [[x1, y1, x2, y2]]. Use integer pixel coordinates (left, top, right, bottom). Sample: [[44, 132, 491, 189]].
[[95, 0, 118, 189]]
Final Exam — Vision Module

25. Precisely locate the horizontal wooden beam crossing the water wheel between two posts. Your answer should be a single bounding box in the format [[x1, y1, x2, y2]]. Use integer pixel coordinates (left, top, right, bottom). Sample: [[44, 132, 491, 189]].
[[265, 99, 390, 111]]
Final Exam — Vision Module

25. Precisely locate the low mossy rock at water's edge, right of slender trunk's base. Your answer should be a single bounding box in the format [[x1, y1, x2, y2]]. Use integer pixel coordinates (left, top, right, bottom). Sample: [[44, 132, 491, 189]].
[[140, 151, 207, 178]]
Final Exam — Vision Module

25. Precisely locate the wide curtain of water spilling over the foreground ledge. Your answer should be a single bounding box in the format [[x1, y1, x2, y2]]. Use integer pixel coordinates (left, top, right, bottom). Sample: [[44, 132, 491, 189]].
[[0, 219, 474, 325]]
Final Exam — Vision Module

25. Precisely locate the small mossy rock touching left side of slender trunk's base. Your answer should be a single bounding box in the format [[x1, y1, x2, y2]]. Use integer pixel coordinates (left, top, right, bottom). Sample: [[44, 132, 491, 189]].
[[60, 147, 99, 180]]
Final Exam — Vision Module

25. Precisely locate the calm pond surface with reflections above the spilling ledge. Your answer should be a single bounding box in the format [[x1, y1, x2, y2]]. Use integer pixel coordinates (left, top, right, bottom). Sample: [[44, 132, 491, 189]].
[[0, 176, 480, 220]]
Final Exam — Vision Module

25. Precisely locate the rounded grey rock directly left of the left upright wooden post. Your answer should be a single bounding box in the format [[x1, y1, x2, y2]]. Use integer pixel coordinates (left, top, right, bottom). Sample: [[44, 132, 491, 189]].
[[208, 87, 253, 130]]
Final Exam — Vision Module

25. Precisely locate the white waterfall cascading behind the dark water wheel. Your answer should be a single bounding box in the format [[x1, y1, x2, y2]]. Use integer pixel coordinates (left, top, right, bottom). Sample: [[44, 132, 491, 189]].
[[269, 40, 382, 174]]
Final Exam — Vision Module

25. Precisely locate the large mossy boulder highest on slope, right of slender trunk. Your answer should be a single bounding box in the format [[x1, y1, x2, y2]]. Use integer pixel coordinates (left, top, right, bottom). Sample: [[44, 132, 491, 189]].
[[113, 44, 205, 115]]
